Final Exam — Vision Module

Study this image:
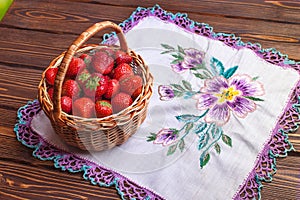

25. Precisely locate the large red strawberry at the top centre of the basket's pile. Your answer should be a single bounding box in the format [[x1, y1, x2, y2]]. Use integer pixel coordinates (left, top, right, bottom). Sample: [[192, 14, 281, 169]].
[[92, 51, 114, 74]]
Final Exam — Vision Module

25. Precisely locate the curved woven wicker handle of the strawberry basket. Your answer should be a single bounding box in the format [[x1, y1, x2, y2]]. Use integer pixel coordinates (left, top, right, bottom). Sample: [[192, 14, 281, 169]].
[[52, 21, 129, 121]]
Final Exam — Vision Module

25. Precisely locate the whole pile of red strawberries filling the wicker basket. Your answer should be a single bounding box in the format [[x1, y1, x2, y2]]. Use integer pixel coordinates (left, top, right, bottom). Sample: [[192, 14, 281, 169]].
[[45, 47, 143, 118]]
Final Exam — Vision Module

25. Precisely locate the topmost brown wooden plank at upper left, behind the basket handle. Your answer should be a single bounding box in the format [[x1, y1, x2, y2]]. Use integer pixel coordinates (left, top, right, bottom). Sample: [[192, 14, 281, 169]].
[[2, 0, 129, 34]]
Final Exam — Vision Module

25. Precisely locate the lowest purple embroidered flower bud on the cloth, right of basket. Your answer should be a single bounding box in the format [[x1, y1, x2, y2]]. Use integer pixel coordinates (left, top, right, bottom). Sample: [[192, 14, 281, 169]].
[[153, 128, 178, 146]]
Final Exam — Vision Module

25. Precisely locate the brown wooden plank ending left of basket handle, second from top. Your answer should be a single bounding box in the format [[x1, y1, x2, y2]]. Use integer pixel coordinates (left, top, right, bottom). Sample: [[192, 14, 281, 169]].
[[0, 28, 76, 71]]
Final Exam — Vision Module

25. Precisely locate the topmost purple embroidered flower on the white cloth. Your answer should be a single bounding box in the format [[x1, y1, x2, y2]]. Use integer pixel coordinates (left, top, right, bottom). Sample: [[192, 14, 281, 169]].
[[171, 48, 204, 73]]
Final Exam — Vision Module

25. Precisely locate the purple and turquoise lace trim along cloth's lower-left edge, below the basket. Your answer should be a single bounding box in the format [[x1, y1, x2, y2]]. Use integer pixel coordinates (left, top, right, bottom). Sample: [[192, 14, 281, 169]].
[[14, 100, 163, 200]]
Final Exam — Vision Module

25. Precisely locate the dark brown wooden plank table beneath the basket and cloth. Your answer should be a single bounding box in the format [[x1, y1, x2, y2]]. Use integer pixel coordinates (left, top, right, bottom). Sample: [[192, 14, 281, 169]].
[[0, 0, 300, 199]]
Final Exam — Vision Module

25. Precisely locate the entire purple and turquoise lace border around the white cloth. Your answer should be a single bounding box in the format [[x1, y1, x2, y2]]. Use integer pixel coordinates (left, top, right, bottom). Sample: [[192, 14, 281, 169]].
[[15, 5, 300, 199]]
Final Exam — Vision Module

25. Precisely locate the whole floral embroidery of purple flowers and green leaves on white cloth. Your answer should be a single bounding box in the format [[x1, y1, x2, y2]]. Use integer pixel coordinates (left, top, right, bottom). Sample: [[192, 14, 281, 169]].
[[147, 44, 265, 168]]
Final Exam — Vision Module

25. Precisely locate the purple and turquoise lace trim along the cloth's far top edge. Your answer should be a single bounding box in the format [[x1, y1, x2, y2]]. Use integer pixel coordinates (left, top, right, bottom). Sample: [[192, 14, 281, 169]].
[[104, 5, 300, 72]]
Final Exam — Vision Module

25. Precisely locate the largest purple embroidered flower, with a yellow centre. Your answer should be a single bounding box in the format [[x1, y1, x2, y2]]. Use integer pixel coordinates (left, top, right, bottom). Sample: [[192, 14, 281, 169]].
[[195, 75, 264, 125]]
